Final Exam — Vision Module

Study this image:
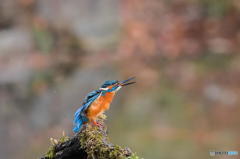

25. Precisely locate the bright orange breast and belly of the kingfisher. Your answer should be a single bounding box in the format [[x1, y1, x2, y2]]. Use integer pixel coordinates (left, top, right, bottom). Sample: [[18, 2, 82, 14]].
[[87, 92, 115, 119]]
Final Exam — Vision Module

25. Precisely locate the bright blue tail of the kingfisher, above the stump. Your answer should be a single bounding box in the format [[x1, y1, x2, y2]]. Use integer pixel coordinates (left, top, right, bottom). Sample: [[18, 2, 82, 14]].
[[73, 108, 88, 133]]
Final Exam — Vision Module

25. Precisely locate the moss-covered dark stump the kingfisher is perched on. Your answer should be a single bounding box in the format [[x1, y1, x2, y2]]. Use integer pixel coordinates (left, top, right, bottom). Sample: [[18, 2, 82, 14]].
[[41, 117, 138, 159]]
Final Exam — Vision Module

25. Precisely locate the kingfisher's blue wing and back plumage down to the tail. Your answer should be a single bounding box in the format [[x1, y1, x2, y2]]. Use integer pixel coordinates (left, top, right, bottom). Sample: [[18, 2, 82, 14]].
[[73, 90, 101, 133]]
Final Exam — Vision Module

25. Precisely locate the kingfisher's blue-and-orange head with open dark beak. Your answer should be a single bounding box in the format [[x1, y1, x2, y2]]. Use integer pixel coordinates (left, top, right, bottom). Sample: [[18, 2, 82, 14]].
[[100, 77, 136, 92]]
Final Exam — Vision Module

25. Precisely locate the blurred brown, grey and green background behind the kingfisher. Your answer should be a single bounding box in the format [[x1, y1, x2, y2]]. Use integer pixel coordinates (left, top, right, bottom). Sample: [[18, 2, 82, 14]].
[[0, 0, 240, 159]]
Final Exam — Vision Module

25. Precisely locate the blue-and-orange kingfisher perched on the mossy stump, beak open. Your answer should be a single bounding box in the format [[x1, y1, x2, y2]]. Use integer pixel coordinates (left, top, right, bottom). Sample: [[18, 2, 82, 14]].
[[73, 77, 136, 133]]
